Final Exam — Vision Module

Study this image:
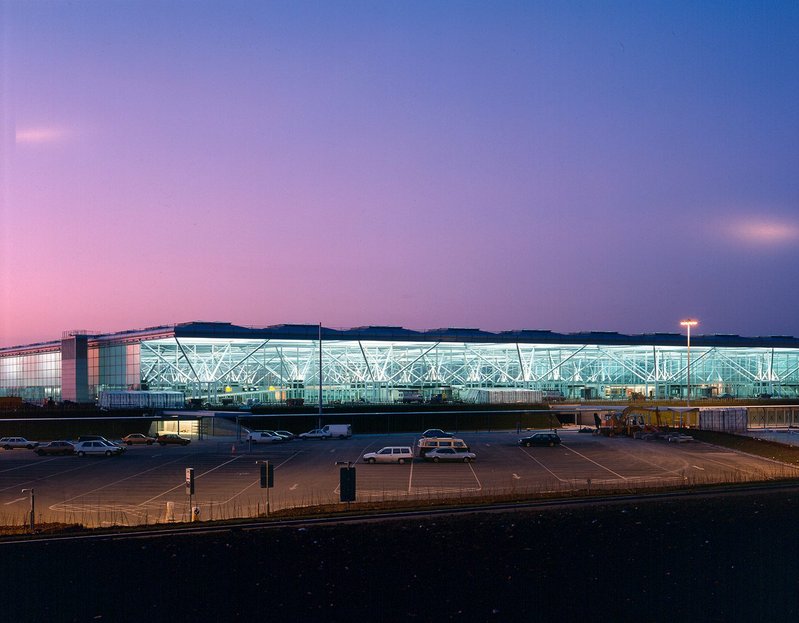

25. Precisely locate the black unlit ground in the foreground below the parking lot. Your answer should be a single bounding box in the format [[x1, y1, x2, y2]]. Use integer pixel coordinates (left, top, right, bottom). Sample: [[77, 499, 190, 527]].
[[0, 491, 799, 622]]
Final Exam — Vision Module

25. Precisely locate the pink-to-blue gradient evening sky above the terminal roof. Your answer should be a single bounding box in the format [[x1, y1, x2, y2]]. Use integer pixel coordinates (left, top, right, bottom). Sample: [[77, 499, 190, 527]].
[[0, 0, 799, 346]]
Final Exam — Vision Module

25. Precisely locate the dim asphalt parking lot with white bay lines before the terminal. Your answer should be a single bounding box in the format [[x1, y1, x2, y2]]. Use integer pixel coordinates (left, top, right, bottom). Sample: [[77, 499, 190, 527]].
[[0, 429, 799, 526]]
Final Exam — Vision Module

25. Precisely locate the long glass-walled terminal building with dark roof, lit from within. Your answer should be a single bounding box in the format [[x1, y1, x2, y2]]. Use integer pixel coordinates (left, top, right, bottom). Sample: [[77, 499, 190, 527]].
[[0, 322, 799, 404]]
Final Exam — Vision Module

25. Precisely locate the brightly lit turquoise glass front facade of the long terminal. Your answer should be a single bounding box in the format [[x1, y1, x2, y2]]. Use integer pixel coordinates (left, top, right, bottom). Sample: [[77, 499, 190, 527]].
[[141, 339, 799, 403]]
